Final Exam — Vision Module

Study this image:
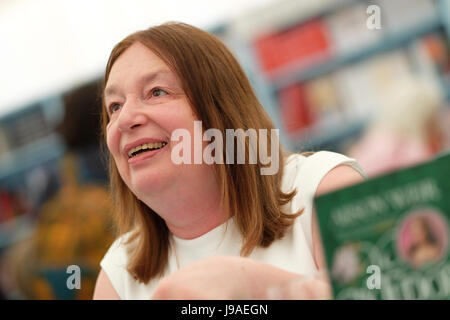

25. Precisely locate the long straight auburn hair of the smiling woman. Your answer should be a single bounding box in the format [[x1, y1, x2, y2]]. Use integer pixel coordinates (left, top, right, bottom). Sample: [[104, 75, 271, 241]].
[[102, 22, 301, 283]]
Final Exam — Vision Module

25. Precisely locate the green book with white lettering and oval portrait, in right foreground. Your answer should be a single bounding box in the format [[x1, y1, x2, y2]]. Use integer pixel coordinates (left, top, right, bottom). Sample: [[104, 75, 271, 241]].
[[314, 153, 450, 300]]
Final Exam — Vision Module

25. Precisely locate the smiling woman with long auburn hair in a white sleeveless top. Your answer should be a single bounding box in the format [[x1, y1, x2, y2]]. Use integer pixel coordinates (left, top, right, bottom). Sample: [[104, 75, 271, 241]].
[[94, 23, 368, 299]]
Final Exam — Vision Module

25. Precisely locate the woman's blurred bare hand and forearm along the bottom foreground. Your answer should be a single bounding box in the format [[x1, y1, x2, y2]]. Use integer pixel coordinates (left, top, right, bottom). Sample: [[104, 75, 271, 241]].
[[152, 257, 331, 300]]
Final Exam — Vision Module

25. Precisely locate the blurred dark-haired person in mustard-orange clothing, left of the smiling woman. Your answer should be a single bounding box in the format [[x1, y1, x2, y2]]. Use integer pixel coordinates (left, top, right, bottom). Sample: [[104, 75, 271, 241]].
[[2, 82, 113, 299]]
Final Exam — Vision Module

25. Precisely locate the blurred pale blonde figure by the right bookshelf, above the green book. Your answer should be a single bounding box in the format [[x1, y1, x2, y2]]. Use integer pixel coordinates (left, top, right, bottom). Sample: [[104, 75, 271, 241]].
[[348, 76, 444, 176]]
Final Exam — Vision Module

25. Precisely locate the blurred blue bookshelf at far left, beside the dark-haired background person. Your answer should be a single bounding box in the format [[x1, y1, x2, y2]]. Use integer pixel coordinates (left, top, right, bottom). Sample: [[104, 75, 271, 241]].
[[0, 96, 65, 251]]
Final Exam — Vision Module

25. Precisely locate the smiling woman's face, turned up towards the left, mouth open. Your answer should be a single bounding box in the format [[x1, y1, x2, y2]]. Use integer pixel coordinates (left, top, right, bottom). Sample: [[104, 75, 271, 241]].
[[105, 42, 207, 205]]
